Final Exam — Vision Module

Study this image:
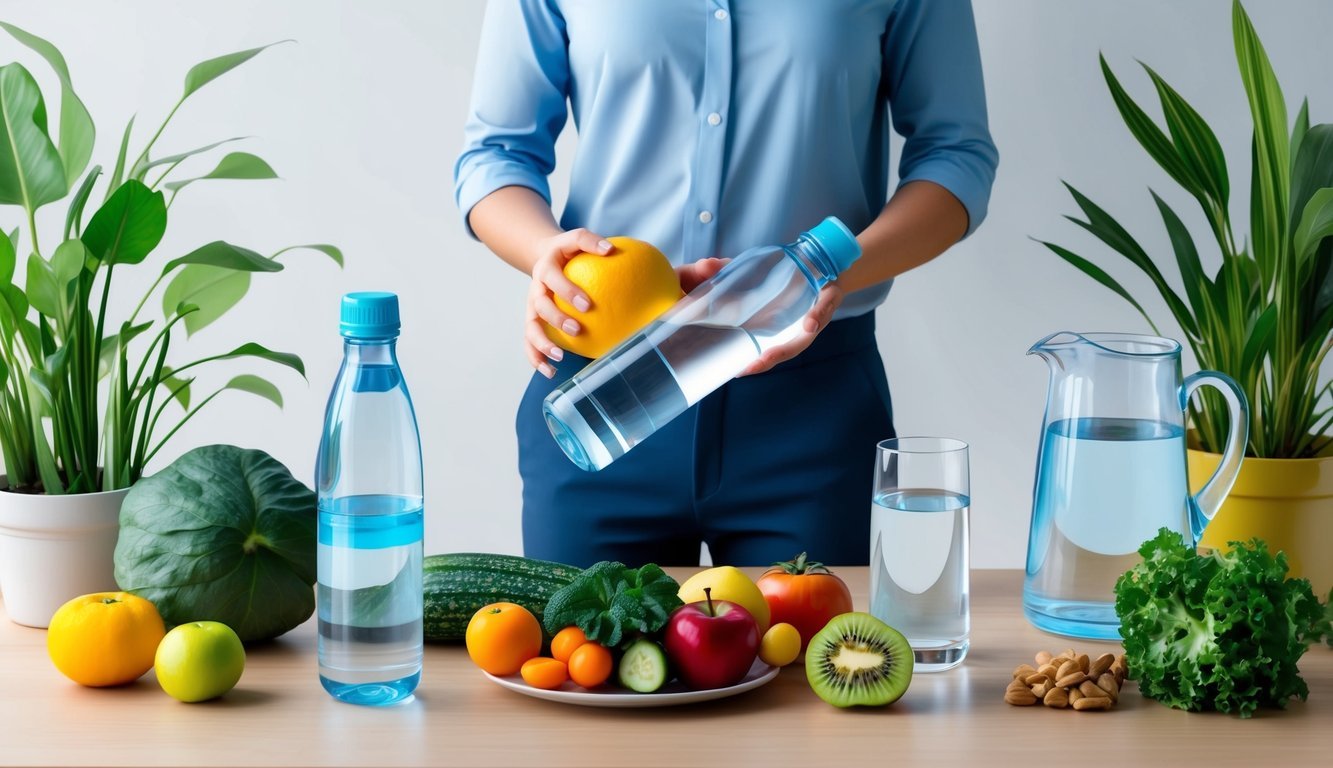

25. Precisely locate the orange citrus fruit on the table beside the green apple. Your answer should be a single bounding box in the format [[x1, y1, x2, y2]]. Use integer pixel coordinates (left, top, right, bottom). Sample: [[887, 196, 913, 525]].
[[47, 592, 167, 688]]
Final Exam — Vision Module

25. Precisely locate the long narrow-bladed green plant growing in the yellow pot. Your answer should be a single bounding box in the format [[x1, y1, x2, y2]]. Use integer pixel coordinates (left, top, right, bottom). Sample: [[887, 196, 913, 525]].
[[1042, 0, 1333, 459]]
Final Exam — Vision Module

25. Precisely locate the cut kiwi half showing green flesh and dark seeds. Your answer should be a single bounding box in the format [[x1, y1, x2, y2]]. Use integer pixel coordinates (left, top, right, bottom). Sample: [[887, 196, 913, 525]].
[[805, 613, 912, 707]]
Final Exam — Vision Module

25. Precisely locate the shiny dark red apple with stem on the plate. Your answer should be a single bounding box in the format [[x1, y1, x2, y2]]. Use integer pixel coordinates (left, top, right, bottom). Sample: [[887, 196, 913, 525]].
[[663, 589, 758, 691]]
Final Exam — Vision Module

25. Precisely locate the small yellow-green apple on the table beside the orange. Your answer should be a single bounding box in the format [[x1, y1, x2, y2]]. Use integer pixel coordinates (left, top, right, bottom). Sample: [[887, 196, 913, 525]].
[[153, 621, 245, 703]]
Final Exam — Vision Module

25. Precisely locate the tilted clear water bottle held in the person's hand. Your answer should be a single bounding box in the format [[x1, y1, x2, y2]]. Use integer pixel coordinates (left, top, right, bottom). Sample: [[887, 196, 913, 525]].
[[543, 216, 861, 471]]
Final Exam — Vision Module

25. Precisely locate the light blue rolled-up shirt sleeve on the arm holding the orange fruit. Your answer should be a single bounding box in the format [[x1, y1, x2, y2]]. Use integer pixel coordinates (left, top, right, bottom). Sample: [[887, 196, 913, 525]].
[[453, 0, 569, 237]]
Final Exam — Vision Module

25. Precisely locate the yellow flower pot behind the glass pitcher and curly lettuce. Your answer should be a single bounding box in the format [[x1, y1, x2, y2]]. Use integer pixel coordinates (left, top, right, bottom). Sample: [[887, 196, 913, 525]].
[[1188, 449, 1333, 600]]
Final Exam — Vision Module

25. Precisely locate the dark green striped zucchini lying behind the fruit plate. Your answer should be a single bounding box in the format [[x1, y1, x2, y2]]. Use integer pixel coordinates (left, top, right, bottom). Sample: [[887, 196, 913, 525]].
[[421, 552, 583, 643]]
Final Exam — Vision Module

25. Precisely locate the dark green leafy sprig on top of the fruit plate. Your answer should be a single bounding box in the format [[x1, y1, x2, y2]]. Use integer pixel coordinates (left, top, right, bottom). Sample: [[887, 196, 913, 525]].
[[543, 560, 681, 648]]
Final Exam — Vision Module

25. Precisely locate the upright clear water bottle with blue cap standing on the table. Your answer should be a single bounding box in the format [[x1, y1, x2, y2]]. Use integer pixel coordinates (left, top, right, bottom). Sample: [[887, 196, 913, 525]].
[[315, 293, 423, 705]]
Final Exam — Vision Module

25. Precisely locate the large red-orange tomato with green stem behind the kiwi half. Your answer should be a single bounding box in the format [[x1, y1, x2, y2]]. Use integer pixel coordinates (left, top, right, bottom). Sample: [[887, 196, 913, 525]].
[[756, 552, 852, 651]]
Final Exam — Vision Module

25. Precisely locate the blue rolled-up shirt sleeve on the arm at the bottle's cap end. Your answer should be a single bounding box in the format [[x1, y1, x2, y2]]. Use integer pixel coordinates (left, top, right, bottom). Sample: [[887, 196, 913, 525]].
[[884, 0, 1000, 235]]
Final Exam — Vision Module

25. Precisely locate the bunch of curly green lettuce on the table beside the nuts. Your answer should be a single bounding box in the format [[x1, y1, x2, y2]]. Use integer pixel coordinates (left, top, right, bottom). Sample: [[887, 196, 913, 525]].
[[1116, 528, 1325, 717]]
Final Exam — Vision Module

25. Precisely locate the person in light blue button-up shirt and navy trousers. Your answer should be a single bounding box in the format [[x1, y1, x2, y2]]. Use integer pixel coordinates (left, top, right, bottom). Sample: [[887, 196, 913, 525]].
[[455, 0, 998, 565]]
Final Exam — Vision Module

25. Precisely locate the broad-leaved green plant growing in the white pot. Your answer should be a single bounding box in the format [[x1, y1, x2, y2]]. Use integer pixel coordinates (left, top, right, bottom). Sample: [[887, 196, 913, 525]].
[[0, 21, 343, 493]]
